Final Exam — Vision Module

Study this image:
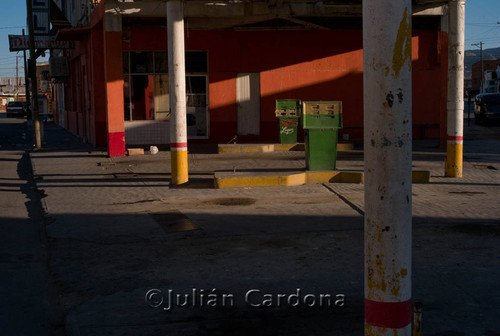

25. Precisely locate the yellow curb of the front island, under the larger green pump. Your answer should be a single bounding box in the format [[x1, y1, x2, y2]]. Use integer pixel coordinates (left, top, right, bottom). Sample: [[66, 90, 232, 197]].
[[214, 170, 430, 189]]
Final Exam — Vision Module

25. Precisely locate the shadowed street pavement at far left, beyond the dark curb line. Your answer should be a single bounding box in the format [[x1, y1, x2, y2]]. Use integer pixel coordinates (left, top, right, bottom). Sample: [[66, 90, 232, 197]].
[[0, 113, 53, 335]]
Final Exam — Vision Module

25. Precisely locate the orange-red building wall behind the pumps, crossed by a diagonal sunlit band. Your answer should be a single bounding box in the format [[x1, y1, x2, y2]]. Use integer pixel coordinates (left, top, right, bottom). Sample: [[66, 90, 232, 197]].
[[123, 26, 446, 142]]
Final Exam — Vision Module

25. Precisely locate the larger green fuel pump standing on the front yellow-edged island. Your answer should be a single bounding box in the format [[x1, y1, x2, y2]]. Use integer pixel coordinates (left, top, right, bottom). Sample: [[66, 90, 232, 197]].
[[302, 101, 342, 170]]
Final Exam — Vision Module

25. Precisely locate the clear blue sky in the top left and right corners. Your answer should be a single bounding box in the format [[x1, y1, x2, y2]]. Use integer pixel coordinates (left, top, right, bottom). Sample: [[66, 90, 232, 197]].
[[0, 0, 500, 77]]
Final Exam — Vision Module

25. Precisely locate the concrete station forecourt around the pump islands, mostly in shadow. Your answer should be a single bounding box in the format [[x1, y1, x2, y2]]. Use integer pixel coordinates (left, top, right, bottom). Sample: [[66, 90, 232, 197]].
[[30, 124, 500, 336]]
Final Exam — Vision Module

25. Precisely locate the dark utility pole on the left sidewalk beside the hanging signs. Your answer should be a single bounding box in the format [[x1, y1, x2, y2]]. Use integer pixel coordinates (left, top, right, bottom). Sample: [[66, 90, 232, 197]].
[[26, 0, 42, 149]]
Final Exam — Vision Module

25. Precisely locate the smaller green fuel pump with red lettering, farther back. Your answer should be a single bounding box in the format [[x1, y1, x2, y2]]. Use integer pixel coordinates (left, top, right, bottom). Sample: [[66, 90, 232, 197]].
[[275, 99, 301, 144]]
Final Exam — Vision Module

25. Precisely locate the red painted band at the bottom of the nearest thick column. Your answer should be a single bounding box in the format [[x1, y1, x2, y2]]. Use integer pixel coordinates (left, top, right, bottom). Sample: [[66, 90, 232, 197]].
[[365, 299, 412, 329]]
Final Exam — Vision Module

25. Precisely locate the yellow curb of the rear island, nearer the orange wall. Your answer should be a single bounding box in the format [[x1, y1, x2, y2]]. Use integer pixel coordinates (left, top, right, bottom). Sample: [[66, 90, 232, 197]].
[[217, 143, 354, 154]]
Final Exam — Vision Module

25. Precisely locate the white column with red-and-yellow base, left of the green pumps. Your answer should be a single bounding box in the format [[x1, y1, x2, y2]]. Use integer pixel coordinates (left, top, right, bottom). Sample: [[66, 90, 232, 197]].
[[167, 0, 188, 185]]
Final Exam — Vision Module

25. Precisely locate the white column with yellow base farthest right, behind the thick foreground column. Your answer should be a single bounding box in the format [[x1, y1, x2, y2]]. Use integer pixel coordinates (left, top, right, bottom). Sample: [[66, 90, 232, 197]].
[[445, 0, 465, 177]]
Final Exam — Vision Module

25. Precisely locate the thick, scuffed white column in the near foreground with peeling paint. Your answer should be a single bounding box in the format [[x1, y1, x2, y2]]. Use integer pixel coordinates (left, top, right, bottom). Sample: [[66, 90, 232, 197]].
[[363, 0, 412, 336]]
